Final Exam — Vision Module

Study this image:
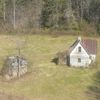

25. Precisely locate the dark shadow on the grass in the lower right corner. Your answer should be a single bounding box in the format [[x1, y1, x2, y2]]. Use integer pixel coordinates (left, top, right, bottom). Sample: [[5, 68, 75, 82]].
[[87, 71, 100, 100]]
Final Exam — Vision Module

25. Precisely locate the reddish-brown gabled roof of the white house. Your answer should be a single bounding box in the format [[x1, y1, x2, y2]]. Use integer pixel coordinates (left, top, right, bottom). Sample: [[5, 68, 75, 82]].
[[69, 39, 97, 54]]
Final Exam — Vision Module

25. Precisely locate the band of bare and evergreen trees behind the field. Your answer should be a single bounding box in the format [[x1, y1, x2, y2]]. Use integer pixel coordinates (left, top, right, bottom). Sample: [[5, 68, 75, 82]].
[[0, 0, 100, 34]]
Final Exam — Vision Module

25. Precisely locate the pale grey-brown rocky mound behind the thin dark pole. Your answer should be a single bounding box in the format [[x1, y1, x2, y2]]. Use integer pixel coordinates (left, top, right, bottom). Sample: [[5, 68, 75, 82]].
[[1, 56, 27, 80]]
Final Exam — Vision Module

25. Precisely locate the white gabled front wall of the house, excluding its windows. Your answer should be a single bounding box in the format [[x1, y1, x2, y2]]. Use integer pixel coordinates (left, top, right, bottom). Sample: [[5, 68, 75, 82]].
[[70, 43, 91, 67]]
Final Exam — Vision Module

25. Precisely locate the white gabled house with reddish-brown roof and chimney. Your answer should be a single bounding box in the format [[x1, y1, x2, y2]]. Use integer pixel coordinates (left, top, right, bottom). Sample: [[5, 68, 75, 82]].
[[67, 37, 97, 67]]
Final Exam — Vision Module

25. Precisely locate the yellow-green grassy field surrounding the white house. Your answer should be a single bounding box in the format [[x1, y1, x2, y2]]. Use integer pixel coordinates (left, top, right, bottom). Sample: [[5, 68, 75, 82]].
[[0, 35, 100, 100]]
